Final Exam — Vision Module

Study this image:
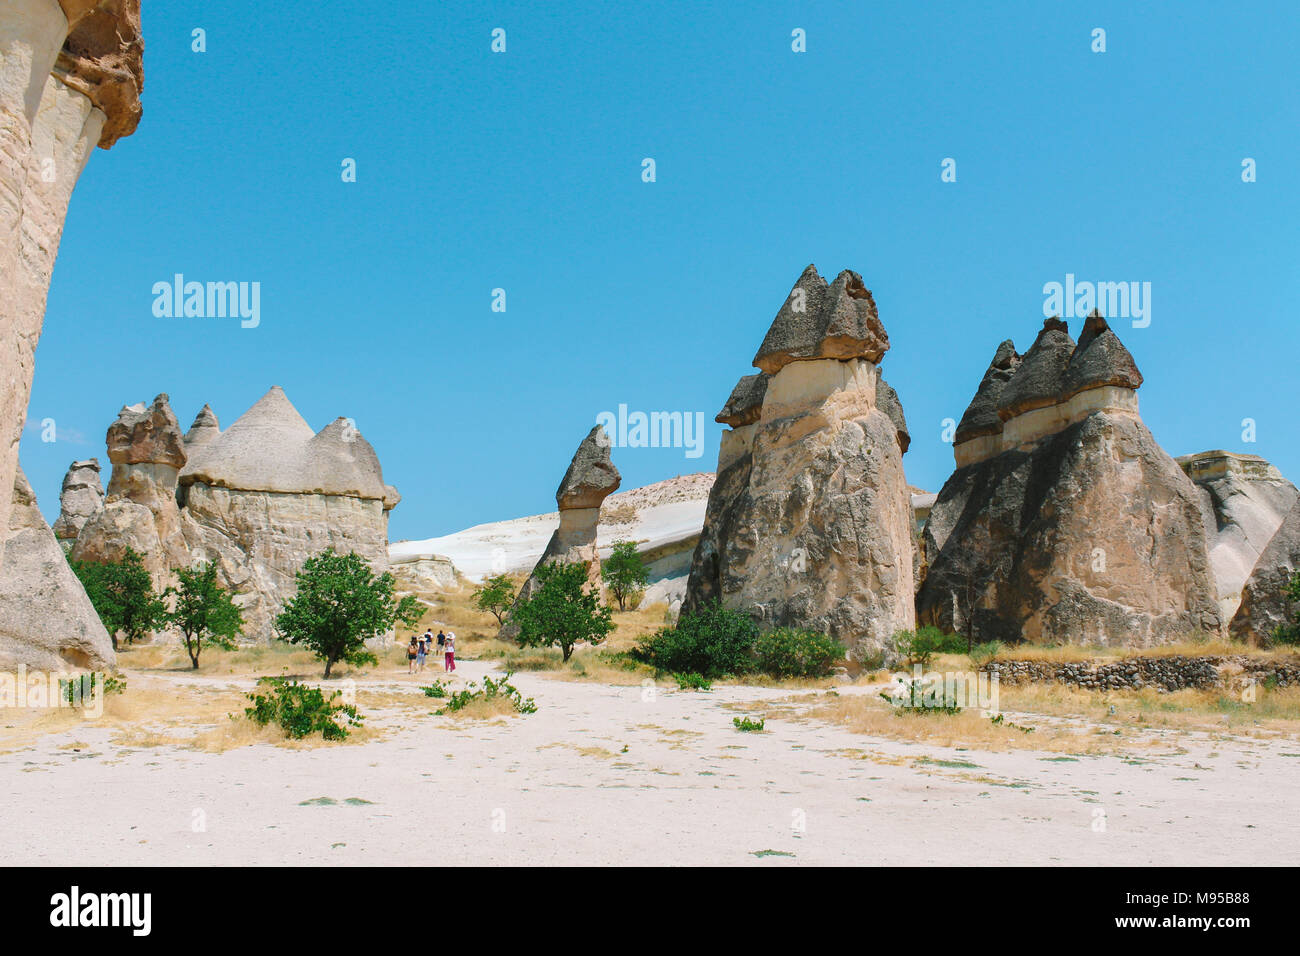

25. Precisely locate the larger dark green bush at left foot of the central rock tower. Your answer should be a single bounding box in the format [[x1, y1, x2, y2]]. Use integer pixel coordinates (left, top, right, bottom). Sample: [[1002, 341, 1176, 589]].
[[632, 601, 758, 678]]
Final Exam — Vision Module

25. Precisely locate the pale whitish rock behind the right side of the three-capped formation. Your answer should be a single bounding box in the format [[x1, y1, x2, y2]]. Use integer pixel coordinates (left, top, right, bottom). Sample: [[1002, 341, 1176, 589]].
[[1178, 451, 1297, 620]]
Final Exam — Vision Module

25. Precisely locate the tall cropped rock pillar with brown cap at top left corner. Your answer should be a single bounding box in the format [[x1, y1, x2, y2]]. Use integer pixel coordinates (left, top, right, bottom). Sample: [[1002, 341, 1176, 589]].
[[0, 0, 143, 567]]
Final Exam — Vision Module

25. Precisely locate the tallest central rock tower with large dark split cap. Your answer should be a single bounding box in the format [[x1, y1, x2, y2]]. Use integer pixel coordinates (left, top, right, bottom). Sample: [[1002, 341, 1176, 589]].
[[683, 265, 914, 652]]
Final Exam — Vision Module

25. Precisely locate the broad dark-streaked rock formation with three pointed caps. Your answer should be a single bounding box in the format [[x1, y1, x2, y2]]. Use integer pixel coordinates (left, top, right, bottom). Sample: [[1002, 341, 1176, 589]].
[[917, 312, 1222, 645]]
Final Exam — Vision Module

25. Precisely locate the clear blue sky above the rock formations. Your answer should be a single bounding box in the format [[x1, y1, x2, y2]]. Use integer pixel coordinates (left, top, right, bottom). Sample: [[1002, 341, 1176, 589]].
[[22, 0, 1300, 540]]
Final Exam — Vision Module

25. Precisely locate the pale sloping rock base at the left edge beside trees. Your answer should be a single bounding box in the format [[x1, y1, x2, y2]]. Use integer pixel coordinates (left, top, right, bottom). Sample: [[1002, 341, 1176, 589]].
[[0, 468, 116, 671]]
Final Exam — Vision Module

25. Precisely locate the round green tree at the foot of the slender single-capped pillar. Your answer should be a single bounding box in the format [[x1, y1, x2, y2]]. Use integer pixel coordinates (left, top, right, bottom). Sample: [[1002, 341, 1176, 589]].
[[511, 562, 614, 661]]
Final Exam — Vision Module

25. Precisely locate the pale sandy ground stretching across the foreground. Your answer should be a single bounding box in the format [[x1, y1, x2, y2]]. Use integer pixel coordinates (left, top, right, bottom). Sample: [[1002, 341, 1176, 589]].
[[0, 661, 1300, 866]]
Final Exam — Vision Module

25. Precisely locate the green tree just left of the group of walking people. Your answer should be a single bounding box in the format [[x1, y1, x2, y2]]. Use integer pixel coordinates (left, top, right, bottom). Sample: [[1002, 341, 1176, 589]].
[[276, 548, 420, 678]]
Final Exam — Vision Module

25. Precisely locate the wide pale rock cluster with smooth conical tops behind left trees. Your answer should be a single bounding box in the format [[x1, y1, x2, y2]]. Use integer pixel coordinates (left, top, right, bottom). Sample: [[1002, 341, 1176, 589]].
[[72, 386, 400, 640]]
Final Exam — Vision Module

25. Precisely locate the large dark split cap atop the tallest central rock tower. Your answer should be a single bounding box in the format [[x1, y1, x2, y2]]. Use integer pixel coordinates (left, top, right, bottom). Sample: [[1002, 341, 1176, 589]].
[[754, 265, 889, 375]]
